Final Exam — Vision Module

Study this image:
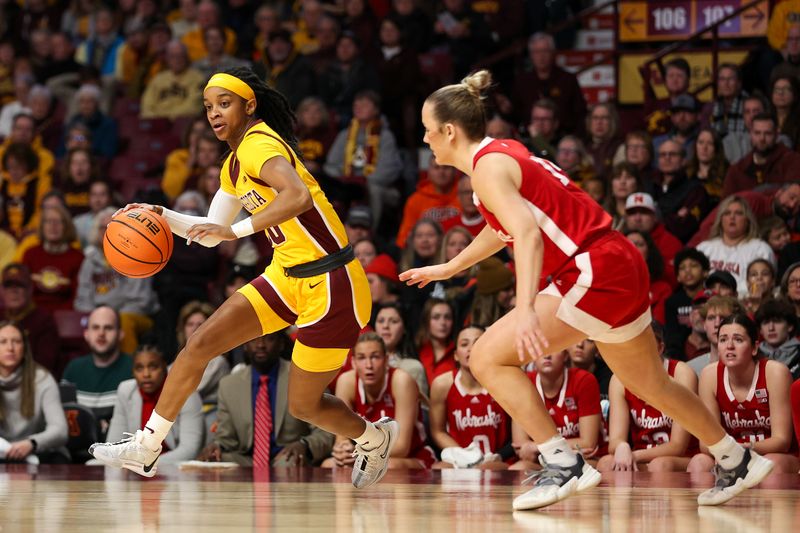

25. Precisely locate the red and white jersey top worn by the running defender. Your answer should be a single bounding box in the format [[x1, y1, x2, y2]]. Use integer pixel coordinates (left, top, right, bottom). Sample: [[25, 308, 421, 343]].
[[472, 137, 611, 279]]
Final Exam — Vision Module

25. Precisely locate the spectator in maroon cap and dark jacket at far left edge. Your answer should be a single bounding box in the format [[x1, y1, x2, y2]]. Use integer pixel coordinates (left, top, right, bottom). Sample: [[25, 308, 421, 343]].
[[2, 263, 61, 379]]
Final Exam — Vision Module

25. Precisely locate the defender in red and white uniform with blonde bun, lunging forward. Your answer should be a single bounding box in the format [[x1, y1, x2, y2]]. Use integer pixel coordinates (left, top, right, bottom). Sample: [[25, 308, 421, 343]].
[[400, 71, 772, 510]]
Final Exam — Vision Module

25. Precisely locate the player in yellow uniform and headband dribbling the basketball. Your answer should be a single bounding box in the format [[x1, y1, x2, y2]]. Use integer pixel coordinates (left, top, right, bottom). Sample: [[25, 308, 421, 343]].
[[90, 68, 397, 488]]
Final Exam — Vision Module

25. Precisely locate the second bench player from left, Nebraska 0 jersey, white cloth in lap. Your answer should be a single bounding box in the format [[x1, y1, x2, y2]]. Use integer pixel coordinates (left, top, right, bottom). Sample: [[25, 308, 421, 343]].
[[430, 325, 514, 470]]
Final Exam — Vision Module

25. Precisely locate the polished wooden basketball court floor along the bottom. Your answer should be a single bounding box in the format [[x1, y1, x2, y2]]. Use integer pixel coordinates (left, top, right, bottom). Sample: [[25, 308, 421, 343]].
[[0, 465, 800, 533]]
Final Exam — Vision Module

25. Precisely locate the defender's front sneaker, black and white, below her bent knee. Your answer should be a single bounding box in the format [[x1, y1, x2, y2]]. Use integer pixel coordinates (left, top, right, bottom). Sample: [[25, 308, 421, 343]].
[[514, 454, 601, 511]]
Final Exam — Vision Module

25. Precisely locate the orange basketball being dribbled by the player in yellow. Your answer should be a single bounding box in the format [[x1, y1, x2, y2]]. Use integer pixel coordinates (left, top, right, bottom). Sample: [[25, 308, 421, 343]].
[[103, 209, 172, 278]]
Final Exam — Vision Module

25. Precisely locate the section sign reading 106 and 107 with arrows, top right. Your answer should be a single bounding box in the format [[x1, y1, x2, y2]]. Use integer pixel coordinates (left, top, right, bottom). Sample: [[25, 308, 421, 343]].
[[619, 0, 769, 42]]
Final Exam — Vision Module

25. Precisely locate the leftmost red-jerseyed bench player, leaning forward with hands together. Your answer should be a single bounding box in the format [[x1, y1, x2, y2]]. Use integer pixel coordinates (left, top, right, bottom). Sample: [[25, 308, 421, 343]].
[[322, 332, 436, 469]]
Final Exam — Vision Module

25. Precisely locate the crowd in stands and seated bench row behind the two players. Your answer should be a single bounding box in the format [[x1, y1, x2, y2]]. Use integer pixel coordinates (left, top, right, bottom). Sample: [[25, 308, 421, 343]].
[[0, 0, 800, 473]]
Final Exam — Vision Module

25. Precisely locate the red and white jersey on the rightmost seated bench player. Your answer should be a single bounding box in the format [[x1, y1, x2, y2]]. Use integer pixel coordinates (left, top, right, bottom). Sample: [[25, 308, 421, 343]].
[[717, 359, 772, 443]]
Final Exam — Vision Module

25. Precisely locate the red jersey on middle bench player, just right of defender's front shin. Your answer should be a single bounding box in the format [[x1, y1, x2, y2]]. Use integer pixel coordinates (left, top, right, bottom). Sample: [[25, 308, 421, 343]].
[[528, 368, 600, 443]]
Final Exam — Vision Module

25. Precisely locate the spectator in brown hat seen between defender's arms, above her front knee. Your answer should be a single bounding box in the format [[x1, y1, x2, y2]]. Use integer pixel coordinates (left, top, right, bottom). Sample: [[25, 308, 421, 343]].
[[469, 257, 515, 327]]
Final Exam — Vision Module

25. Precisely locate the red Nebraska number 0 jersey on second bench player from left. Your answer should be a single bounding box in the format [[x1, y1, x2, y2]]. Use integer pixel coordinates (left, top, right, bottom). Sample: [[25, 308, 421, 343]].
[[445, 370, 511, 453]]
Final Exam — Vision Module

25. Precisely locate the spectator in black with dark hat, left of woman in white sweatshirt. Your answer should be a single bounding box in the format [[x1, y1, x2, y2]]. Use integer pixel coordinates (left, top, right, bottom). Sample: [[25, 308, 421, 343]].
[[664, 248, 709, 359]]
